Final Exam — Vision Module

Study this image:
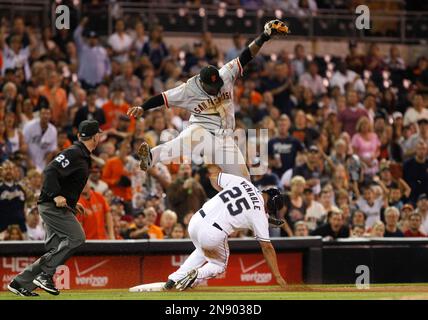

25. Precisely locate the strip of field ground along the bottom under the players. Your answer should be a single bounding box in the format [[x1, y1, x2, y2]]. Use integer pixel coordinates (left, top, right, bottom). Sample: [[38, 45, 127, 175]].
[[0, 284, 428, 300]]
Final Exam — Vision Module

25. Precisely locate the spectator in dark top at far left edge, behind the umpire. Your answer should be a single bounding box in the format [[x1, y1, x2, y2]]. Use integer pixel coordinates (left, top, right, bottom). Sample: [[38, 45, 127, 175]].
[[0, 161, 27, 232]]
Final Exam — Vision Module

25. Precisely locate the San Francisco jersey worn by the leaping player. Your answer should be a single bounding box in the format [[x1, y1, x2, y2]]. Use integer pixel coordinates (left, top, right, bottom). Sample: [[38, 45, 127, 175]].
[[162, 58, 242, 131]]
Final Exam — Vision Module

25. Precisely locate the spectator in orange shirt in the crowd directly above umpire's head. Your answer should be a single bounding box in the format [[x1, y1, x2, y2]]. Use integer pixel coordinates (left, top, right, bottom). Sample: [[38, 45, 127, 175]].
[[39, 71, 67, 126]]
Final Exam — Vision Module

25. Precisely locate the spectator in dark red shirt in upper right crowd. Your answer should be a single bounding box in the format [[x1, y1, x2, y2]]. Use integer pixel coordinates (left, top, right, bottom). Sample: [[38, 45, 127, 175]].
[[338, 90, 368, 137]]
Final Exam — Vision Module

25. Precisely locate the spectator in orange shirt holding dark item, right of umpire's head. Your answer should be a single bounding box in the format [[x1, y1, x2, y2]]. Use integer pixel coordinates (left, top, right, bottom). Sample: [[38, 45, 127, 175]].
[[102, 140, 132, 206]]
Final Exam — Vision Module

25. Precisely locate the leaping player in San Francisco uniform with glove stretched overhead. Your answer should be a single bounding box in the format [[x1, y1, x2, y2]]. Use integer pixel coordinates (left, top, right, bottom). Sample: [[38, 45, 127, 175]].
[[128, 20, 289, 180]]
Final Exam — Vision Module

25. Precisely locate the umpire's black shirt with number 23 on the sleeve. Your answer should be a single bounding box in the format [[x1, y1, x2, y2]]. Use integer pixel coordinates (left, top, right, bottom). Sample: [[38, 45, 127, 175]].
[[39, 142, 91, 208]]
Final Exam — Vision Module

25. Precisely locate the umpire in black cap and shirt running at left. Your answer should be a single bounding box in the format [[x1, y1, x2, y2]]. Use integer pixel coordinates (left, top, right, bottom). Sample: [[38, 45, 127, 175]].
[[8, 120, 101, 296]]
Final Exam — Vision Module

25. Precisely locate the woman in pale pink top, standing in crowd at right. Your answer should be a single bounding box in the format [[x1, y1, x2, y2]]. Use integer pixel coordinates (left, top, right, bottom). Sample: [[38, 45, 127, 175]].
[[351, 116, 380, 175]]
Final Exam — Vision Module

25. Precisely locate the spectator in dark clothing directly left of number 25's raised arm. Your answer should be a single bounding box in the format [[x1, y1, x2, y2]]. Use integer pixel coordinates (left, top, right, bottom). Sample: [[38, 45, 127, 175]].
[[166, 164, 207, 223]]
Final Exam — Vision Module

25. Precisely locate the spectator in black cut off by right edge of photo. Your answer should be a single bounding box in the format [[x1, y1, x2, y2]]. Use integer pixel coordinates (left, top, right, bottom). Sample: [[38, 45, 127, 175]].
[[403, 139, 428, 204]]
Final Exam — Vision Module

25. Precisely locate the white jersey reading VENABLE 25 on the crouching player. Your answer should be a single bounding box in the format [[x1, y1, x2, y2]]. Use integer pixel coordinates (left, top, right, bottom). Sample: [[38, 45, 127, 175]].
[[197, 173, 270, 241]]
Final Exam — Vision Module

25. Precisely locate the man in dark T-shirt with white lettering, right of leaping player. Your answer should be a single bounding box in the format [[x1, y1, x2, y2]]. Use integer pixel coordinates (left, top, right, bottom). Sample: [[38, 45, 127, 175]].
[[268, 114, 304, 177]]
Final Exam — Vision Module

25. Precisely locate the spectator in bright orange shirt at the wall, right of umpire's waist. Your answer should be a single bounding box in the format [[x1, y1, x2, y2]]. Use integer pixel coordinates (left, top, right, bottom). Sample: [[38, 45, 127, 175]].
[[77, 180, 115, 240]]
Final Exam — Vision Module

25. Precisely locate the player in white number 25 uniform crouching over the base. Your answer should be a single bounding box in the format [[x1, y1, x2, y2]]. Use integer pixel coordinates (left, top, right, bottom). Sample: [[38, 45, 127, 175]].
[[163, 165, 286, 291]]
